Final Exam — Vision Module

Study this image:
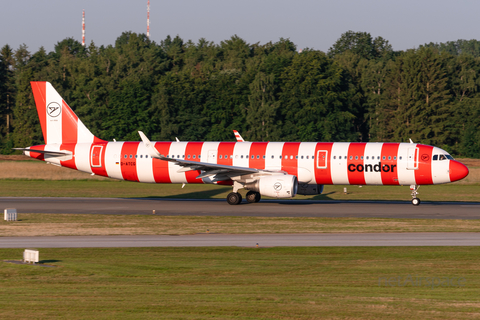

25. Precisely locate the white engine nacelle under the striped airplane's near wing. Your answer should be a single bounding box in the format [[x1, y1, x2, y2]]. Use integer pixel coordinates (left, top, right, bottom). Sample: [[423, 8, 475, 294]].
[[245, 174, 298, 198]]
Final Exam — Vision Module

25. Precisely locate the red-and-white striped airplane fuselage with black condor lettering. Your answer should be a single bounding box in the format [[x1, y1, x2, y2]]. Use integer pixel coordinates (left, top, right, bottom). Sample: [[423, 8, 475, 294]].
[[26, 141, 468, 185]]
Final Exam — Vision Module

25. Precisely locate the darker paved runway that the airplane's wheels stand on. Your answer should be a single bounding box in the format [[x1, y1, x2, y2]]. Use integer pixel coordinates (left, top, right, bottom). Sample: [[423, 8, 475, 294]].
[[0, 197, 480, 219]]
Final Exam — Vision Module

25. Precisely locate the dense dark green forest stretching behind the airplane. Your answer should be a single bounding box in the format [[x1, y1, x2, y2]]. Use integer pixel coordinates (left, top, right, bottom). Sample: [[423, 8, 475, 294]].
[[0, 31, 480, 158]]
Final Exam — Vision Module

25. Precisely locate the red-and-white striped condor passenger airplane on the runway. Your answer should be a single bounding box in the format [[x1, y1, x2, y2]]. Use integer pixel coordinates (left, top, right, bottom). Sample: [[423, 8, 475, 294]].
[[16, 81, 468, 206]]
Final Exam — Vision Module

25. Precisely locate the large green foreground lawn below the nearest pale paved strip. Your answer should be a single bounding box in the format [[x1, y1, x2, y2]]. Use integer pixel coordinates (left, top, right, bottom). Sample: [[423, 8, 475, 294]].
[[0, 247, 480, 319]]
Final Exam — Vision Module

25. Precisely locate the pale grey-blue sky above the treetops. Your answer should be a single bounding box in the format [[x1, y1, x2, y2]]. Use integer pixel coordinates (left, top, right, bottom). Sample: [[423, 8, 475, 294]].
[[0, 0, 480, 53]]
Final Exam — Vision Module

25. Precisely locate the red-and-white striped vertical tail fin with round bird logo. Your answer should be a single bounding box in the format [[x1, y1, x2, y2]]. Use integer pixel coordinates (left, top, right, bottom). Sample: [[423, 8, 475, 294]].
[[30, 81, 102, 144]]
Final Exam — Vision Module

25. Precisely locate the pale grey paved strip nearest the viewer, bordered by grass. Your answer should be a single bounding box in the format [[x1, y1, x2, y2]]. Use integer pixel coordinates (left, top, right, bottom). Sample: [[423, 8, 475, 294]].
[[0, 232, 480, 249]]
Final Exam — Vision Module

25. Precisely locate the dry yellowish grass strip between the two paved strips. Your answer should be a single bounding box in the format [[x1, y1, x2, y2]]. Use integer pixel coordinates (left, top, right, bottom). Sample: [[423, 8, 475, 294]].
[[0, 213, 480, 239]]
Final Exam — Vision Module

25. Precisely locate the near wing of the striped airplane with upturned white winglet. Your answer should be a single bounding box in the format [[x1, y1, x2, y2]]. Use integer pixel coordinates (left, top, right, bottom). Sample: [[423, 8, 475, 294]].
[[138, 131, 266, 180]]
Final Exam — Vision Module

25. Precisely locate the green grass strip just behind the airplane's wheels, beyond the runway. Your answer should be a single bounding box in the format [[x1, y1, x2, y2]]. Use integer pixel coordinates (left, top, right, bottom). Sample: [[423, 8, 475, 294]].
[[0, 180, 480, 201]]
